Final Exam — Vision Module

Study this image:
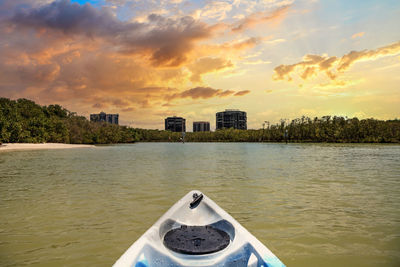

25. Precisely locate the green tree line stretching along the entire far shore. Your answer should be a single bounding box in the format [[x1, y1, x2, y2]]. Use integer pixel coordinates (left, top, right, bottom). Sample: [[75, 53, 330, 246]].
[[0, 98, 400, 146]]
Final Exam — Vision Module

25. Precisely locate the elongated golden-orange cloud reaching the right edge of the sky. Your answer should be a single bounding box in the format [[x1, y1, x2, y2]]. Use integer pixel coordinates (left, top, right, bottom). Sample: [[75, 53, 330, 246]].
[[273, 42, 400, 81]]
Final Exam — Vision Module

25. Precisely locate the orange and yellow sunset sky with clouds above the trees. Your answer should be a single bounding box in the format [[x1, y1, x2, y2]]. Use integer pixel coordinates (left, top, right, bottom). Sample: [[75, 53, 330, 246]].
[[0, 0, 400, 131]]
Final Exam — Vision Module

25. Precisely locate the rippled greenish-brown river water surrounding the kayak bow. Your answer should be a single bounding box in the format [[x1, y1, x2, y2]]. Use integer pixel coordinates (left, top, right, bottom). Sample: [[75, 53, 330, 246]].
[[0, 143, 400, 267]]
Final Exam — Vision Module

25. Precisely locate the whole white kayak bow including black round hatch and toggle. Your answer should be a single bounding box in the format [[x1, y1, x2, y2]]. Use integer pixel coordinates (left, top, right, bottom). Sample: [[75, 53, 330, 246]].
[[114, 191, 285, 267]]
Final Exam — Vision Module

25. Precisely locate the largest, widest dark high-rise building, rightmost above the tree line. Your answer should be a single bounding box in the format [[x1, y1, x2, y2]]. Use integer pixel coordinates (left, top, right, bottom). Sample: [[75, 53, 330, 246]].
[[216, 109, 247, 130]]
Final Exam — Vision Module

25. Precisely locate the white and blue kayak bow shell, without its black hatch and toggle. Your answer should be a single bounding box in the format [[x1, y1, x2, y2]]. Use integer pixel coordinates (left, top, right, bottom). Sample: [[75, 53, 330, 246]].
[[114, 191, 285, 267]]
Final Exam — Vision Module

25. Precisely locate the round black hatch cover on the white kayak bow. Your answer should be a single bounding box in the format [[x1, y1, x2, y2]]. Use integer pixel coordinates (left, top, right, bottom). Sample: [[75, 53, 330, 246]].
[[164, 225, 230, 255]]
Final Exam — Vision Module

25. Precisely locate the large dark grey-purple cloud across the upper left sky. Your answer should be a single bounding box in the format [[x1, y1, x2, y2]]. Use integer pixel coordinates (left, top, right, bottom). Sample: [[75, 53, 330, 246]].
[[8, 0, 215, 67]]
